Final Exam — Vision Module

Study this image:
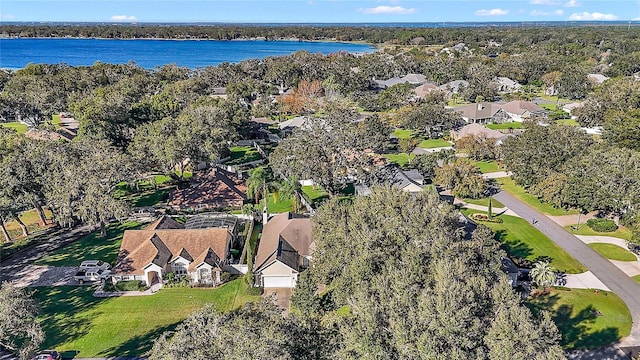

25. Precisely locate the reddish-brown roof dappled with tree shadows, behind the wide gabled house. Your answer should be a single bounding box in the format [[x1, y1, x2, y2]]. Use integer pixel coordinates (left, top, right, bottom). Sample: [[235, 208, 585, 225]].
[[169, 168, 247, 209]]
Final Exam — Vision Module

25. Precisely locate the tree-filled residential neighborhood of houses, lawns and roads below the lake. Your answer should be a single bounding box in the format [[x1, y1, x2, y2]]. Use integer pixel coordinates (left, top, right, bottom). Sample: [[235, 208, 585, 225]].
[[0, 21, 640, 360]]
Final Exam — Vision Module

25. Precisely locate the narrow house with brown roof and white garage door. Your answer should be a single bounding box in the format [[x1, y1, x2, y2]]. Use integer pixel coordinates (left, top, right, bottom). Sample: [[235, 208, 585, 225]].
[[253, 212, 314, 288]]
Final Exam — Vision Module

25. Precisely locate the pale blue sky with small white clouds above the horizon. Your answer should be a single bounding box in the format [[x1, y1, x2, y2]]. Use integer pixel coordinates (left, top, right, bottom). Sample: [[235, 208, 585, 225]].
[[0, 0, 640, 23]]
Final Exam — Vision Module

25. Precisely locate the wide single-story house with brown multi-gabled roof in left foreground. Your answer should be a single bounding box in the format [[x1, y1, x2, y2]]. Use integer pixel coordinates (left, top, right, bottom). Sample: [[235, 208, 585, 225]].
[[112, 216, 232, 286]]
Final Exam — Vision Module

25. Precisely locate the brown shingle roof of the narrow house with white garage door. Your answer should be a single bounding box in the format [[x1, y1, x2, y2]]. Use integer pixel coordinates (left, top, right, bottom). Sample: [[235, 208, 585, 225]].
[[255, 213, 313, 271]]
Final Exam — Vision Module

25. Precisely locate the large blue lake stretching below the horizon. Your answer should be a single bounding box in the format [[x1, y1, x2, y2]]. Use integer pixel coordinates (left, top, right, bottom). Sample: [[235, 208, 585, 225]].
[[0, 38, 375, 69]]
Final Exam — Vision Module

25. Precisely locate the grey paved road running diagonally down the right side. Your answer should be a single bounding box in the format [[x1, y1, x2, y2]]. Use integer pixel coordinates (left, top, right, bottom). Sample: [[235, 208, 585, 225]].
[[494, 191, 640, 346]]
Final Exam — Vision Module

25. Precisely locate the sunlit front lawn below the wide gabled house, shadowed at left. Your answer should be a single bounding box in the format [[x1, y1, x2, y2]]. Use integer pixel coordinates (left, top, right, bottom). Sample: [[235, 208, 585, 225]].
[[34, 279, 259, 357]]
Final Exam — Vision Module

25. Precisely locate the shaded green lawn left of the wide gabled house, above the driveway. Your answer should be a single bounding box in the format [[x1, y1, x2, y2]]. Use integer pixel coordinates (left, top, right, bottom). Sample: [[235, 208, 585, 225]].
[[36, 222, 142, 266]]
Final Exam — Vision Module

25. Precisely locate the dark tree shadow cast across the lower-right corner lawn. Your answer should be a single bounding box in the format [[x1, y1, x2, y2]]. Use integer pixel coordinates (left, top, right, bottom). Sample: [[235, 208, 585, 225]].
[[525, 290, 621, 349]]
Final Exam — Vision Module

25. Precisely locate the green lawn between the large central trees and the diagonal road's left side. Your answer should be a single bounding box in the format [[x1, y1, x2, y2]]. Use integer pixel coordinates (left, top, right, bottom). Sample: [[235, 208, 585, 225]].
[[462, 209, 587, 274]]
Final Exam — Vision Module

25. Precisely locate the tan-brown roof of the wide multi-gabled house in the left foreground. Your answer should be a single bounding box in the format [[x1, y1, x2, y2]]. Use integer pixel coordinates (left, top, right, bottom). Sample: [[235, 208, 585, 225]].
[[114, 228, 231, 275]]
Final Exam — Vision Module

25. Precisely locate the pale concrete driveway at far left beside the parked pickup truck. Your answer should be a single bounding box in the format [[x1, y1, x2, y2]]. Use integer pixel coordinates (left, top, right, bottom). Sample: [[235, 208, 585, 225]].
[[7, 265, 78, 287]]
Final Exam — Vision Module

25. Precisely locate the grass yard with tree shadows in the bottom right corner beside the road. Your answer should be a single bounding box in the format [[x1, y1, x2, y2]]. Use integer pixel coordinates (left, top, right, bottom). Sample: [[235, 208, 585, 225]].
[[526, 288, 631, 349]]
